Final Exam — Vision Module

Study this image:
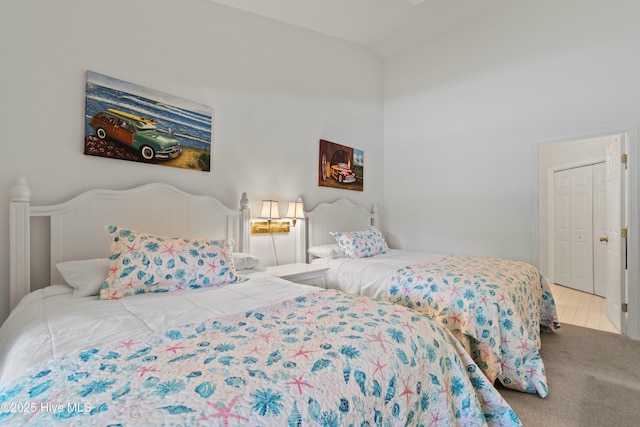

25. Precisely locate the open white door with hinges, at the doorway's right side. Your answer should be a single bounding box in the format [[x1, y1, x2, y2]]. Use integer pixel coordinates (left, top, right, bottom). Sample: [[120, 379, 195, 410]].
[[605, 136, 626, 333]]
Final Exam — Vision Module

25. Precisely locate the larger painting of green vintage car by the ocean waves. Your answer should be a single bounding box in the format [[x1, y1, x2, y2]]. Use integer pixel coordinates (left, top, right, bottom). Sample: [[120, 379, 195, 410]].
[[84, 71, 213, 172]]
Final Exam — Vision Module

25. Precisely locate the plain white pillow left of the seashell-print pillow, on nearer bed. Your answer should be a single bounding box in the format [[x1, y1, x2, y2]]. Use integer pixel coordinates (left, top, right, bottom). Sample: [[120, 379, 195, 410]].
[[56, 258, 110, 298]]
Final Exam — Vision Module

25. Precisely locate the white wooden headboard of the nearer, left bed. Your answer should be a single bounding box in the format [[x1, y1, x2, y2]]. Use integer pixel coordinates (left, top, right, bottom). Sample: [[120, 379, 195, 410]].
[[9, 177, 250, 310]]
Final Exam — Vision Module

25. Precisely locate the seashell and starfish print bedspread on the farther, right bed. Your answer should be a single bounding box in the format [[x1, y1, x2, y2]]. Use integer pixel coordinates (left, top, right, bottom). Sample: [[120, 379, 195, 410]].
[[389, 255, 559, 397]]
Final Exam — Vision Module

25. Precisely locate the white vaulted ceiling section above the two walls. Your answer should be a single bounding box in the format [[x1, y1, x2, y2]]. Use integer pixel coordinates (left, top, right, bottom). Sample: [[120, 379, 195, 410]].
[[211, 0, 513, 58]]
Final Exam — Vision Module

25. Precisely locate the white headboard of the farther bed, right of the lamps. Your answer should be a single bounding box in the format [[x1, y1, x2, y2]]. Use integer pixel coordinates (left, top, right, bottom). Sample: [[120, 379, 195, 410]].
[[302, 199, 380, 262]]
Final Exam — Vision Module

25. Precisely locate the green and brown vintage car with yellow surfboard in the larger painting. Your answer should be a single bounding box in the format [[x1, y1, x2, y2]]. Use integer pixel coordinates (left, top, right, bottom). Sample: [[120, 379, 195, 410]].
[[90, 108, 182, 160]]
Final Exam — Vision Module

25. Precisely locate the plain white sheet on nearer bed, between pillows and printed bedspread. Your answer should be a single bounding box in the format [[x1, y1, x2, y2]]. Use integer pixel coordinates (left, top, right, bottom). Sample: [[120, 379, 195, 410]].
[[0, 273, 318, 385]]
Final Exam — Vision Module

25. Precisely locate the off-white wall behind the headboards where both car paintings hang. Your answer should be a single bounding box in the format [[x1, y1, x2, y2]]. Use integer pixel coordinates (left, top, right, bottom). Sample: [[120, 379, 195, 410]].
[[0, 0, 383, 322]]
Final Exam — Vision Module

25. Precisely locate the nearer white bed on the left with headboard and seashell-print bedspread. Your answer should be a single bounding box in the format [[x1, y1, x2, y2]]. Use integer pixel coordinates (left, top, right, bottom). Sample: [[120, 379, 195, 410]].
[[0, 181, 520, 426]]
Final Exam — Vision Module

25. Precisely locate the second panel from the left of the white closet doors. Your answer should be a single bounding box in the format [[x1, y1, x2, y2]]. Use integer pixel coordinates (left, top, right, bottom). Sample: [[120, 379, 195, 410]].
[[571, 165, 593, 294]]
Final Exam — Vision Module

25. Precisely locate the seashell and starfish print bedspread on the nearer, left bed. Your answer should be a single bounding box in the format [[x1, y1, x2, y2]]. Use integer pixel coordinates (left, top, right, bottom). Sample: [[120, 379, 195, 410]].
[[0, 290, 521, 427]]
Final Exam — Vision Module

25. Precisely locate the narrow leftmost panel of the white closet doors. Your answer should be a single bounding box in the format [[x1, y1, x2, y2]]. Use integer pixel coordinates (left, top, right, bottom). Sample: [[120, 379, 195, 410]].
[[553, 170, 571, 287]]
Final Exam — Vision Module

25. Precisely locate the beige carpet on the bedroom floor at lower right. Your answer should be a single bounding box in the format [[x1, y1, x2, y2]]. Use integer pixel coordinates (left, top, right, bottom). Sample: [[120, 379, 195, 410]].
[[498, 325, 640, 427]]
